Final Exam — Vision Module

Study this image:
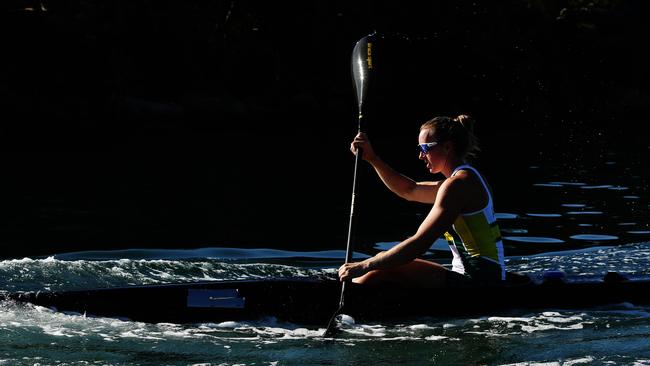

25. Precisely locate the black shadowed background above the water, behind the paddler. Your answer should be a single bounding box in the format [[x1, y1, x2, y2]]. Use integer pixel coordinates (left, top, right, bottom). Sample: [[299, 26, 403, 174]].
[[0, 0, 650, 257]]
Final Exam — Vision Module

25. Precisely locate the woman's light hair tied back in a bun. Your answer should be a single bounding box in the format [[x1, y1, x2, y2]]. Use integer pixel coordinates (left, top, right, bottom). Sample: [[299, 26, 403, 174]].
[[420, 114, 480, 158]]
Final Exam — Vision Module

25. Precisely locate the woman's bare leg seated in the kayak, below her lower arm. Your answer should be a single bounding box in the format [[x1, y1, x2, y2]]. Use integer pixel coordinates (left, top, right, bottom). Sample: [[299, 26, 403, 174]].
[[352, 259, 449, 288]]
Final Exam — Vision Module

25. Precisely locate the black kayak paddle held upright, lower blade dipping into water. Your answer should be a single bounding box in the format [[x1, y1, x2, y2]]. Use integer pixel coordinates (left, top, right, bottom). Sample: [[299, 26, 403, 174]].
[[324, 33, 375, 337]]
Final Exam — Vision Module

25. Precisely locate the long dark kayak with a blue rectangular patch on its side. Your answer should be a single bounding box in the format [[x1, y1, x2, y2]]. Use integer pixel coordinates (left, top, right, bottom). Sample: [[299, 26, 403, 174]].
[[0, 272, 650, 325]]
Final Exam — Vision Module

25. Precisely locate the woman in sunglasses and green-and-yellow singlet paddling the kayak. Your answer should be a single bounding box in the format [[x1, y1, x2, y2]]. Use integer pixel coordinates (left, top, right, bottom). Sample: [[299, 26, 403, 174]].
[[339, 115, 505, 287]]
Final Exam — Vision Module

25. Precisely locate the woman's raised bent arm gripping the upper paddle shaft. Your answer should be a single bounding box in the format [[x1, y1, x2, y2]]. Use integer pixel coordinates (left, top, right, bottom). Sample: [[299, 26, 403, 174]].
[[350, 133, 442, 204]]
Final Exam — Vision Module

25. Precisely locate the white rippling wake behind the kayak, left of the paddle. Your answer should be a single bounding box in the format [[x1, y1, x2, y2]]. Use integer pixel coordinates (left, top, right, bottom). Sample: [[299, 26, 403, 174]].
[[0, 257, 334, 291]]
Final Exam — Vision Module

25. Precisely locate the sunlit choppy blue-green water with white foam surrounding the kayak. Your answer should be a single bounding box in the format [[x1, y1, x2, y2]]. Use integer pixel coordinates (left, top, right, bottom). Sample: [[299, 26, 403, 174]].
[[0, 242, 650, 365]]
